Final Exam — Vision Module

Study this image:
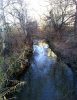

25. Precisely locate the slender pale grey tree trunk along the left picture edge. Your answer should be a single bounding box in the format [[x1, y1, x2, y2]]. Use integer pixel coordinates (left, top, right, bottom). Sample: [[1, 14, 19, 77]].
[[0, 0, 7, 72]]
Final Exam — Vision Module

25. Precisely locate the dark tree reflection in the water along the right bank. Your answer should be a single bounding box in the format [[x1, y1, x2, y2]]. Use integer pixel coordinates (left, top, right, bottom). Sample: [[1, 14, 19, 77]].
[[51, 62, 75, 100]]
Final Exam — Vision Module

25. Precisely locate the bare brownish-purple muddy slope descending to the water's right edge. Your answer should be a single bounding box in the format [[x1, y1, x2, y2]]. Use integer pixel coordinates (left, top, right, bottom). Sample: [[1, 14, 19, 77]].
[[47, 40, 77, 74]]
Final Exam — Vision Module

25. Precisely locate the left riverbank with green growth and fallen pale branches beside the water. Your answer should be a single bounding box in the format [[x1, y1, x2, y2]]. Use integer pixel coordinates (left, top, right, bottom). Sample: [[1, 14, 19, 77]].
[[0, 44, 33, 100]]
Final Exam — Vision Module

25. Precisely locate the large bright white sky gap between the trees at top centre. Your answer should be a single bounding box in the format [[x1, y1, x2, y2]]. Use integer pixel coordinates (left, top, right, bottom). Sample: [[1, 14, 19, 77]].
[[27, 0, 49, 22]]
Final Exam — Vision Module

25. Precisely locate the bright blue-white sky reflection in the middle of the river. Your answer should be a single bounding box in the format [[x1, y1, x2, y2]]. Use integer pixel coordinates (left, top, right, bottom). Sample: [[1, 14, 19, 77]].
[[32, 45, 55, 76]]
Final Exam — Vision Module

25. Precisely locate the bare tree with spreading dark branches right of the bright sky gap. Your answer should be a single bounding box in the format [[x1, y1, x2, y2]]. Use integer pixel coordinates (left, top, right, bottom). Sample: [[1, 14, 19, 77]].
[[47, 0, 74, 31]]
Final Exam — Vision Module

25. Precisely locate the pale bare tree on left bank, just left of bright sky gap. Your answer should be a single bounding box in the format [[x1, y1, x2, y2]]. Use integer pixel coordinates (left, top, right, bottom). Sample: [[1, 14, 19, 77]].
[[10, 0, 27, 36]]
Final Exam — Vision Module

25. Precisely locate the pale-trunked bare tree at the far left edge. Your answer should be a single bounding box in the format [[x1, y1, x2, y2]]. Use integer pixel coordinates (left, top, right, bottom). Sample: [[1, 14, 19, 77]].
[[0, 0, 10, 57]]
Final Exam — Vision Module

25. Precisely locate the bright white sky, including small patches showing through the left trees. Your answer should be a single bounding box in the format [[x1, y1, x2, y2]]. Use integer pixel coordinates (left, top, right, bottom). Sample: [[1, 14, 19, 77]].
[[1, 0, 49, 24]]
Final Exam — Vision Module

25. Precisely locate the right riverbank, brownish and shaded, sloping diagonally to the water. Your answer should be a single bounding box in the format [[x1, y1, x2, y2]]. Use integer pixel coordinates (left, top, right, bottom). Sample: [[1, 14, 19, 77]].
[[47, 36, 77, 75]]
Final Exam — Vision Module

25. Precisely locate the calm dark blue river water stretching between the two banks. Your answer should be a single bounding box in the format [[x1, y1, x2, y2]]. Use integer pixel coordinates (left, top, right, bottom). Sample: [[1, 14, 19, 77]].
[[18, 42, 77, 100]]
